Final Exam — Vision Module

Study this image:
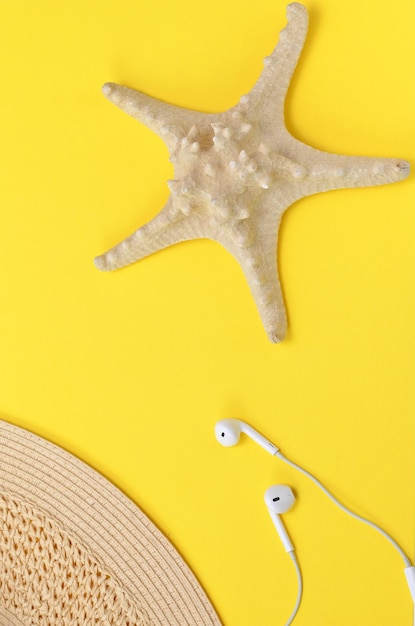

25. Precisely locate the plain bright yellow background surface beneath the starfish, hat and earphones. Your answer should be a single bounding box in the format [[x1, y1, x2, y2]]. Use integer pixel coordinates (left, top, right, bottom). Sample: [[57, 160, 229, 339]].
[[0, 0, 415, 626]]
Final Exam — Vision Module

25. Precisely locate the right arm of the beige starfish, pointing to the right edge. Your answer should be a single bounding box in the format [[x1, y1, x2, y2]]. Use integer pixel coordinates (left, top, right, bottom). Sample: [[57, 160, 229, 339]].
[[278, 133, 410, 197]]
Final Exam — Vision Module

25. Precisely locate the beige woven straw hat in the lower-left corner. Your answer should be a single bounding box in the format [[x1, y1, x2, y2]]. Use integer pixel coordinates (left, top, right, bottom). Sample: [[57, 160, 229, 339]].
[[0, 421, 221, 626]]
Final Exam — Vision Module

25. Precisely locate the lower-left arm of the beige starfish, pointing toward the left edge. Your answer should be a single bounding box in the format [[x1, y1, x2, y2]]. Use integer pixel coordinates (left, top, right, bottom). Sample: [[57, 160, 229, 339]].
[[94, 197, 203, 272]]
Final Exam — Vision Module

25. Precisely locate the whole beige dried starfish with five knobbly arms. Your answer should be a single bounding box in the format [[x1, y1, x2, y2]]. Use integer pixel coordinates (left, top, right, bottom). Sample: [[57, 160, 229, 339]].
[[95, 2, 409, 343]]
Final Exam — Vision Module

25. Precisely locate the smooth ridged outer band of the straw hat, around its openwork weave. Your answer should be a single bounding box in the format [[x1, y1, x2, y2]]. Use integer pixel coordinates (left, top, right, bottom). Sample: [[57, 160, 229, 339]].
[[0, 421, 221, 626]]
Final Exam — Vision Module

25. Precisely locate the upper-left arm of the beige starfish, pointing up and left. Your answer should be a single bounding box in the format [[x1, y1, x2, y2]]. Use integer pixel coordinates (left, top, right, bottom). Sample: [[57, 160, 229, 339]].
[[102, 83, 209, 152]]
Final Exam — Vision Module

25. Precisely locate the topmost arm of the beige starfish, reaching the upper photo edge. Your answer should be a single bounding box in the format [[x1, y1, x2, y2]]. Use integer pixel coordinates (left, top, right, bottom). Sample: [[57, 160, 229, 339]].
[[239, 2, 308, 127]]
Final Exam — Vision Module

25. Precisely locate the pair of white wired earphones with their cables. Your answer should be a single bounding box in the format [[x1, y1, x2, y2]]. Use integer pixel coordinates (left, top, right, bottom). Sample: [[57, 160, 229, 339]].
[[215, 419, 415, 626]]
